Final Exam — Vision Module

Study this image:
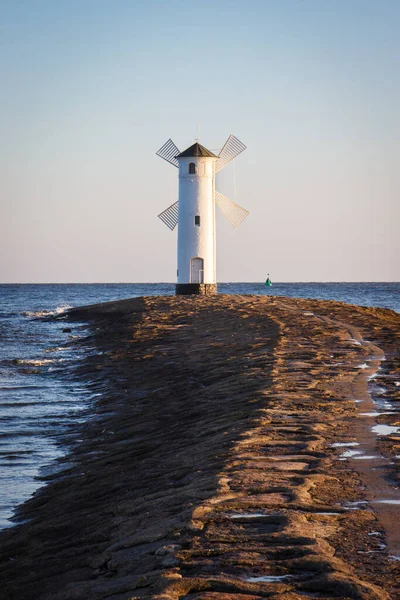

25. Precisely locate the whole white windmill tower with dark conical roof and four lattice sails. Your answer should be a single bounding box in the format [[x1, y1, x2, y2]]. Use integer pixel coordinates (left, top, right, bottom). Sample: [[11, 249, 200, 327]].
[[156, 135, 249, 295]]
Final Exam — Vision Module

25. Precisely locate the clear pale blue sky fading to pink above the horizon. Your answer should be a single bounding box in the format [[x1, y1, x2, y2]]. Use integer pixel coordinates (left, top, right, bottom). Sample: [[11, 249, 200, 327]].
[[0, 0, 400, 282]]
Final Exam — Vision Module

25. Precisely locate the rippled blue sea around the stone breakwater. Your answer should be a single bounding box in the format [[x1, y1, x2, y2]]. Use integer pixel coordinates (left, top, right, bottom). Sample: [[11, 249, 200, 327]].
[[0, 283, 400, 528]]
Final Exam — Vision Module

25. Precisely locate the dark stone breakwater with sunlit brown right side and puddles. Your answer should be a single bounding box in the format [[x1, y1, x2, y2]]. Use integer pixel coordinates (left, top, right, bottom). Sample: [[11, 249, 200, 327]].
[[0, 296, 400, 600]]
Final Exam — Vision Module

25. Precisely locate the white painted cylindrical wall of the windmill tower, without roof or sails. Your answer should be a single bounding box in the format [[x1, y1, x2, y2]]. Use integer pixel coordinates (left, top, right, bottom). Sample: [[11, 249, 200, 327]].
[[178, 156, 217, 283]]
